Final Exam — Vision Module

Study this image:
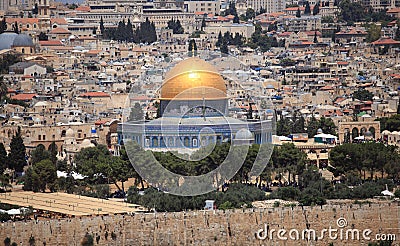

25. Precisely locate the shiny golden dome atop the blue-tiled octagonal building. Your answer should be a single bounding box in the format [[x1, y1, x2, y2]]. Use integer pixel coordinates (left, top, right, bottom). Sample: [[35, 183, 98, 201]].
[[161, 57, 227, 100]]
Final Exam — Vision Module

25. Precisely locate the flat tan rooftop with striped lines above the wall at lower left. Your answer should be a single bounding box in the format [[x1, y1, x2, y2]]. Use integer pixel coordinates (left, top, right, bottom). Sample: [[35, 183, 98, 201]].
[[0, 191, 143, 216]]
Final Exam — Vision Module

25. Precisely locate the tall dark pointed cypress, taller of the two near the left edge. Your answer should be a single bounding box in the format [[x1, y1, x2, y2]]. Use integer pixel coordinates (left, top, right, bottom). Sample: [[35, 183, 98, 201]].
[[8, 127, 26, 172]]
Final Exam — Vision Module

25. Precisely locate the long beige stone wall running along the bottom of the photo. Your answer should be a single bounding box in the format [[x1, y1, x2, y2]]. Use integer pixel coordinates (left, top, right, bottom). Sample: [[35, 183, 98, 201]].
[[0, 202, 400, 245]]
